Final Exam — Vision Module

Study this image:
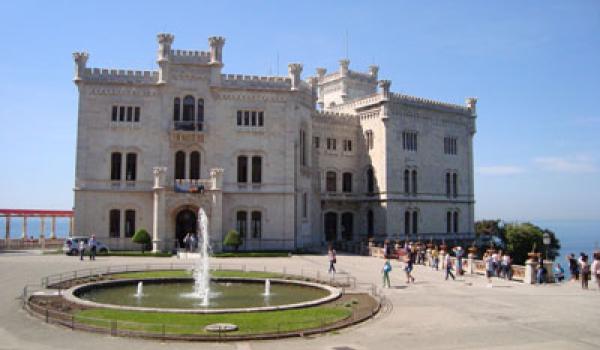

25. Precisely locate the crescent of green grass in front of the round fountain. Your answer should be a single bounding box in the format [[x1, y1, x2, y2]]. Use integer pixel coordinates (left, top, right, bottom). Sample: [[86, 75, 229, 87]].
[[75, 306, 352, 335]]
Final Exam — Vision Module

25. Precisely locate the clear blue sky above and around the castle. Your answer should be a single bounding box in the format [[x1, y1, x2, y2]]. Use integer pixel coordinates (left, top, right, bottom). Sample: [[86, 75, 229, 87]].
[[0, 1, 600, 220]]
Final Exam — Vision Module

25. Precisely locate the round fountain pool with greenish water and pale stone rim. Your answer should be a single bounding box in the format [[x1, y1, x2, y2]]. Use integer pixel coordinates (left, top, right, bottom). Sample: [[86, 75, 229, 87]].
[[65, 278, 341, 313]]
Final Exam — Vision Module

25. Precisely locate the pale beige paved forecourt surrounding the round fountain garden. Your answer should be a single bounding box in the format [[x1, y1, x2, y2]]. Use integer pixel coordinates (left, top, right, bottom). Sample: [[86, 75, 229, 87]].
[[0, 253, 600, 350]]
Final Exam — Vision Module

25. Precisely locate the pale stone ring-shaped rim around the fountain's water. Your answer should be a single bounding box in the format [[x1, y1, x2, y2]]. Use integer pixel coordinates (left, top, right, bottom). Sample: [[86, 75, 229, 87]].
[[63, 277, 342, 314]]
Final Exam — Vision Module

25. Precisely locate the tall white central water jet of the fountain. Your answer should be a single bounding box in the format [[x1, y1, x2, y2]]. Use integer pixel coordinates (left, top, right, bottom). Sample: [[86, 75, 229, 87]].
[[194, 208, 210, 306]]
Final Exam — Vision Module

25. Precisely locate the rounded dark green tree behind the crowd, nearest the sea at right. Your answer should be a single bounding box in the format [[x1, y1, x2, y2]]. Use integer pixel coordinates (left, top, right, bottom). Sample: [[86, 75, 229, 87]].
[[505, 222, 560, 265]]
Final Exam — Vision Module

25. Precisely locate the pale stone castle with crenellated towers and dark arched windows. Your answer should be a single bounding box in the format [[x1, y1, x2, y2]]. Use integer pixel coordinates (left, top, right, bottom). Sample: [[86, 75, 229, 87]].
[[73, 34, 477, 251]]
